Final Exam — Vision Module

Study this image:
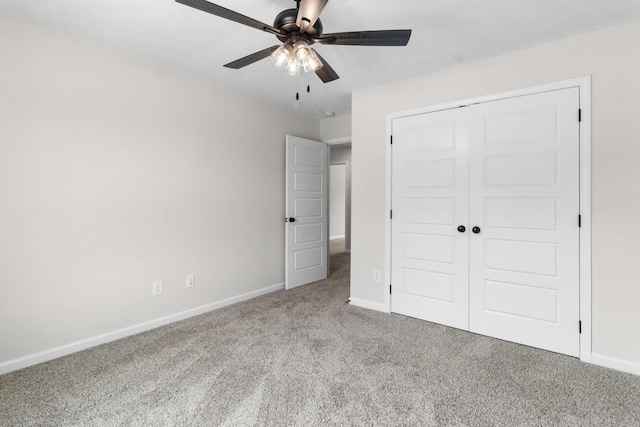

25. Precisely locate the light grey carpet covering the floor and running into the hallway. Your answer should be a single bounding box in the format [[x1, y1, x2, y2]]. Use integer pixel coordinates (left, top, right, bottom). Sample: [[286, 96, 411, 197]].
[[0, 249, 640, 426]]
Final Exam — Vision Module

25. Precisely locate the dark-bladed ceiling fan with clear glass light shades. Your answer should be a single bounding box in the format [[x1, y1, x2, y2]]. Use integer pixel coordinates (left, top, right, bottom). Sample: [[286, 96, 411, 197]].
[[176, 0, 411, 83]]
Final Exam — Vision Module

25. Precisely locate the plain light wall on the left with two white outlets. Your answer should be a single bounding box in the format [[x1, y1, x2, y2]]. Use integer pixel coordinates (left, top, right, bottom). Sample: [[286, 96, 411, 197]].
[[0, 14, 320, 372]]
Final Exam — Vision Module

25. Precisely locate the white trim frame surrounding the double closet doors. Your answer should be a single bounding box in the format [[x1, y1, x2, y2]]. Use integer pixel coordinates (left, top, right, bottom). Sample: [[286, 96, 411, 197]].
[[384, 76, 592, 362]]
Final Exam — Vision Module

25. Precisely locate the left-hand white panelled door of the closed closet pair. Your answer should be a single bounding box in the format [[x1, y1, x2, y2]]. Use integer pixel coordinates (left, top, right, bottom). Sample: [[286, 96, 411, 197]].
[[391, 108, 469, 329]]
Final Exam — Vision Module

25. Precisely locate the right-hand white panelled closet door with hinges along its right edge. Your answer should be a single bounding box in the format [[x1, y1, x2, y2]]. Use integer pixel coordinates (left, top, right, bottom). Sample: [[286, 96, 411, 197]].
[[469, 88, 580, 356]]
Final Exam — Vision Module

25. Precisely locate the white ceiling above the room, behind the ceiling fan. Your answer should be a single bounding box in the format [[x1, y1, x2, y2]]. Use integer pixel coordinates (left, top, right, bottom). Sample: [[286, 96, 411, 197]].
[[0, 0, 640, 118]]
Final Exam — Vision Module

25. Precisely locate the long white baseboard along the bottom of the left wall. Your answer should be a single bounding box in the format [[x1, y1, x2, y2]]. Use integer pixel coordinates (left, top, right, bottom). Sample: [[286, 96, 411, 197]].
[[0, 283, 284, 375]]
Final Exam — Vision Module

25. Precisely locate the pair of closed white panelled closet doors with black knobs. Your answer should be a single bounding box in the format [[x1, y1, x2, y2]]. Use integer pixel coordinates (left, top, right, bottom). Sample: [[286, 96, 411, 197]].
[[391, 88, 580, 356]]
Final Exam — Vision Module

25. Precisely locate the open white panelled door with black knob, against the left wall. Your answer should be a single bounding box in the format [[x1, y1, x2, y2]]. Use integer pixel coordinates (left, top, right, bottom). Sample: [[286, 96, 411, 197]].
[[285, 135, 329, 289]]
